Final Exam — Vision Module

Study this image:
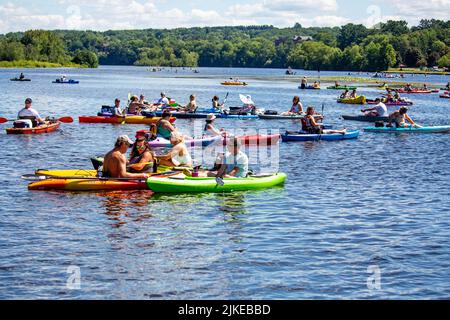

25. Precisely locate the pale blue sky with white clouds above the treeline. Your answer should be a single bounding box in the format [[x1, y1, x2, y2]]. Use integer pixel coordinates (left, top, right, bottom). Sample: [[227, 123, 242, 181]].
[[0, 0, 450, 33]]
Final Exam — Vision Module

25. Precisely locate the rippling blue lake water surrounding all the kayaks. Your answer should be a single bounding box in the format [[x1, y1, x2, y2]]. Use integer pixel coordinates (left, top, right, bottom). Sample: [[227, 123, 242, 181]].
[[0, 67, 450, 299]]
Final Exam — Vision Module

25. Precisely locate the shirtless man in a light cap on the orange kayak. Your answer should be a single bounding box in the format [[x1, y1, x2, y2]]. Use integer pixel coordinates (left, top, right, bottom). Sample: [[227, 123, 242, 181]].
[[102, 135, 149, 179]]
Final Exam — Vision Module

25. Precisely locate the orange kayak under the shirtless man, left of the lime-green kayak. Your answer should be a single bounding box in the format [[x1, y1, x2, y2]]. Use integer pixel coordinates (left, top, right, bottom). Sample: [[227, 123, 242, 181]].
[[28, 177, 147, 191]]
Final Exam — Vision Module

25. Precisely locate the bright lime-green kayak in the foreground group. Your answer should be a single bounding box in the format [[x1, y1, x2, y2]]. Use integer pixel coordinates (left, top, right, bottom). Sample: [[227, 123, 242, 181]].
[[147, 173, 287, 193]]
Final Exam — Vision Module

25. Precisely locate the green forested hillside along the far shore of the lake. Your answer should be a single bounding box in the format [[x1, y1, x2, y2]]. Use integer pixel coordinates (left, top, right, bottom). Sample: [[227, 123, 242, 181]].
[[0, 19, 450, 71]]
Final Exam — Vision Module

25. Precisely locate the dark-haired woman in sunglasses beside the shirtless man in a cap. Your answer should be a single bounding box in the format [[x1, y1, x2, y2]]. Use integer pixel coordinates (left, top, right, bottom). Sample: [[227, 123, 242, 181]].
[[128, 135, 155, 173]]
